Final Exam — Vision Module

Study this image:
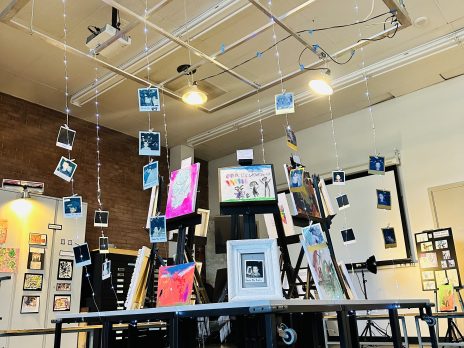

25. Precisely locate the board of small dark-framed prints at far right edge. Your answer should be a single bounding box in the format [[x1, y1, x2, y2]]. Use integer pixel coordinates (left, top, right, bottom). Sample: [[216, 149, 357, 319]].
[[415, 228, 461, 291]]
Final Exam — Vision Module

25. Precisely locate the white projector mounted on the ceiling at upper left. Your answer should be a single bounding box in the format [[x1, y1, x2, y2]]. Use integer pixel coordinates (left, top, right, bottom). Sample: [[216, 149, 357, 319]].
[[85, 24, 131, 57]]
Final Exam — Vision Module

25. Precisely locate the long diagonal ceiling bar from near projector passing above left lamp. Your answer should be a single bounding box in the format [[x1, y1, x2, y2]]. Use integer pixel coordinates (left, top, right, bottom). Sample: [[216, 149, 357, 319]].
[[102, 0, 259, 89]]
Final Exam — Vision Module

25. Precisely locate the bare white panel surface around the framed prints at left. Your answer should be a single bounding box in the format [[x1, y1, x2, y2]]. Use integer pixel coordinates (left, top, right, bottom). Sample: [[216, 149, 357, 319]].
[[0, 189, 87, 348]]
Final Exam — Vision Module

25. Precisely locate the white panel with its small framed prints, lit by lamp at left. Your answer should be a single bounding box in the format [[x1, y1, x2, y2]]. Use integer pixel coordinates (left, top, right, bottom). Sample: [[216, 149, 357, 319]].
[[0, 189, 87, 348]]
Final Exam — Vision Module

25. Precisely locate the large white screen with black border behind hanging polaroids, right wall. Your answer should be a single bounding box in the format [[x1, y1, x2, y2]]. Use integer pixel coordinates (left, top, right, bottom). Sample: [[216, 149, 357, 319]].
[[327, 166, 411, 265]]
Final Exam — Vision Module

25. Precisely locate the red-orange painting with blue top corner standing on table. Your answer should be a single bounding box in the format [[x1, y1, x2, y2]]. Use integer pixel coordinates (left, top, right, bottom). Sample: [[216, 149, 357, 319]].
[[156, 262, 195, 307]]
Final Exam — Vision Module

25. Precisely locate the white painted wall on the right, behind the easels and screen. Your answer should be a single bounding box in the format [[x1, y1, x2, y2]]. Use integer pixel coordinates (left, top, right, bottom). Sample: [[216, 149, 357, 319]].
[[207, 76, 464, 332]]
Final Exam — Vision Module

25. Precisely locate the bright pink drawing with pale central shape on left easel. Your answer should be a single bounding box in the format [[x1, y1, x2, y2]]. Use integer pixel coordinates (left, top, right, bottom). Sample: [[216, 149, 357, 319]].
[[166, 163, 200, 219]]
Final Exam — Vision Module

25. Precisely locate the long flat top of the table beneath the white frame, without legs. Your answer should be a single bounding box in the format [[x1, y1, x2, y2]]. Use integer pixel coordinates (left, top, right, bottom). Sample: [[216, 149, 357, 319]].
[[56, 299, 430, 321]]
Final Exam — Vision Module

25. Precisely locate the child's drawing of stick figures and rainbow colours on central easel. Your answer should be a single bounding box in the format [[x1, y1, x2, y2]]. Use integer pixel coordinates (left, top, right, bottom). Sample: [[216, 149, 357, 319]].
[[219, 164, 277, 203]]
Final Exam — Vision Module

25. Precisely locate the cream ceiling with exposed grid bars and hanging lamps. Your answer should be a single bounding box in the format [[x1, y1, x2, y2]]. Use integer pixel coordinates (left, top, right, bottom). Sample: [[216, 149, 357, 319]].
[[0, 0, 464, 159]]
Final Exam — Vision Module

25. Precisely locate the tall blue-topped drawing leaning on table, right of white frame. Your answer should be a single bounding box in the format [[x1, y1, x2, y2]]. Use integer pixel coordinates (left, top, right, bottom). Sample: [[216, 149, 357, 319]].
[[300, 232, 346, 300]]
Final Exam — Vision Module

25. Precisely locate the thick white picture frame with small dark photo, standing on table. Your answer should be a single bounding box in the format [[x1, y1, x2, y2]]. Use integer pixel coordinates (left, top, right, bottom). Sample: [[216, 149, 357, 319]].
[[227, 239, 283, 301]]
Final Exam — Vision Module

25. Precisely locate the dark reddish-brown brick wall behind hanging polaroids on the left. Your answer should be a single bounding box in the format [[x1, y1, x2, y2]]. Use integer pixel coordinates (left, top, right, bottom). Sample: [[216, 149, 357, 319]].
[[0, 93, 208, 253]]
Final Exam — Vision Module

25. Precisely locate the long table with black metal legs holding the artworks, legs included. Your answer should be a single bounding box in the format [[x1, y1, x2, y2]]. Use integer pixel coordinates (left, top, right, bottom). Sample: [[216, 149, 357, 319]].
[[54, 299, 438, 348]]
